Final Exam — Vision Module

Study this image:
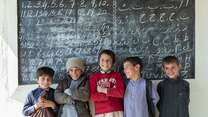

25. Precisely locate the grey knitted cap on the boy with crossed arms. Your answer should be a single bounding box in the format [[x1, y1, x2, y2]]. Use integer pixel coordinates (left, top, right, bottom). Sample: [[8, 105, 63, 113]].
[[66, 57, 85, 72]]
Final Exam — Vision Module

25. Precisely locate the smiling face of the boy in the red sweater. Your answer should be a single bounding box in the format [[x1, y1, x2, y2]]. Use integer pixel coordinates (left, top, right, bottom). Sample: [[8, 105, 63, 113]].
[[99, 54, 113, 71]]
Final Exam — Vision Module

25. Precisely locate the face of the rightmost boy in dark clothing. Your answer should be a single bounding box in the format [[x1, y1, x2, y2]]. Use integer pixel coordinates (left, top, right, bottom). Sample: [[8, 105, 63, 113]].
[[163, 63, 181, 79]]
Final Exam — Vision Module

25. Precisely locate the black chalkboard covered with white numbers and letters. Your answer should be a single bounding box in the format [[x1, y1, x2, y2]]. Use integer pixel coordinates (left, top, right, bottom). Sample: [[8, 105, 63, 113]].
[[18, 0, 195, 85]]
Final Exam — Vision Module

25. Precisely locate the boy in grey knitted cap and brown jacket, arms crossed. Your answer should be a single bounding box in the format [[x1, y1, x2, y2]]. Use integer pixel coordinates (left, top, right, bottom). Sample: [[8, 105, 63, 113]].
[[55, 57, 90, 117]]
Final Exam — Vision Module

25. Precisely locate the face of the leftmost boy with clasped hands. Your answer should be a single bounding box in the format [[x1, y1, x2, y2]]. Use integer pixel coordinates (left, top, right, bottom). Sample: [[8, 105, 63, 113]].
[[37, 74, 52, 89]]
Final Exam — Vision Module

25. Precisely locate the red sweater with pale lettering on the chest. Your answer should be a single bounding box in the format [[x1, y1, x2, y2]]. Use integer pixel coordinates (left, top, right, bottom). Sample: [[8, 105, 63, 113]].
[[89, 72, 124, 115]]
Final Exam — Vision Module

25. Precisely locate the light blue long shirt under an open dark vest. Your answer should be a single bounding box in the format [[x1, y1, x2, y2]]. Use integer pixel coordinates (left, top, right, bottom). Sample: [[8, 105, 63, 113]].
[[124, 78, 159, 117]]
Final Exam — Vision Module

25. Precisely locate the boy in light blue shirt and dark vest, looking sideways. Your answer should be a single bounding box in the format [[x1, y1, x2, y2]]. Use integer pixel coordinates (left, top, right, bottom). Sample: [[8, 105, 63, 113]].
[[123, 57, 159, 117]]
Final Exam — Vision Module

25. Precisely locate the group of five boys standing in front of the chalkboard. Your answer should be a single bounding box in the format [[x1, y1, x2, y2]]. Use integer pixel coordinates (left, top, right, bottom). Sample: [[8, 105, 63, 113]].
[[23, 50, 189, 117]]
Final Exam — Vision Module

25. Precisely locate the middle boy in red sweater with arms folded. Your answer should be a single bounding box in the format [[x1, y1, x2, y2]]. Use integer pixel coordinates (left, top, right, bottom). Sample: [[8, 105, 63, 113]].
[[89, 50, 124, 117]]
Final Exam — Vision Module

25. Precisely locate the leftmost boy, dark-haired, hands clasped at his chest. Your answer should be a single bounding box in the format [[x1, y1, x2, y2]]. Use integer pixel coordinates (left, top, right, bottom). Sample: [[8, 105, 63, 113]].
[[23, 67, 57, 117]]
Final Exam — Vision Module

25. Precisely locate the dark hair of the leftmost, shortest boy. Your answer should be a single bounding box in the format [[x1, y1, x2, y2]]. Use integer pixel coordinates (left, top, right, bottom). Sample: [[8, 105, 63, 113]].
[[36, 66, 55, 78]]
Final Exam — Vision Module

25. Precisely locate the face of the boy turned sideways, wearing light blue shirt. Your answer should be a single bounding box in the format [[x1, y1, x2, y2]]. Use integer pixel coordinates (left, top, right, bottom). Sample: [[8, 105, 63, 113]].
[[123, 61, 140, 79]]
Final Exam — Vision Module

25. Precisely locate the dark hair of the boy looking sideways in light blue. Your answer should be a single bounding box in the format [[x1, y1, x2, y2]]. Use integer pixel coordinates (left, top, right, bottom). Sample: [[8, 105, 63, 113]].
[[123, 56, 143, 70]]
